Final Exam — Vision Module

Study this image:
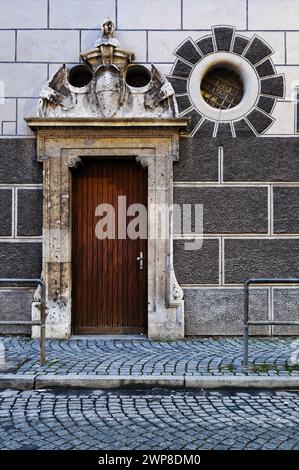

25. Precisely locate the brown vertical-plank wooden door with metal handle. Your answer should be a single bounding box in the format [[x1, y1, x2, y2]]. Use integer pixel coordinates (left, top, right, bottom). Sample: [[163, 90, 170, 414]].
[[72, 159, 147, 334]]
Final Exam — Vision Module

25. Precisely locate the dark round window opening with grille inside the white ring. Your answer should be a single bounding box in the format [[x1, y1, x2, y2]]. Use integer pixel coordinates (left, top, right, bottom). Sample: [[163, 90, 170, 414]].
[[201, 67, 244, 109]]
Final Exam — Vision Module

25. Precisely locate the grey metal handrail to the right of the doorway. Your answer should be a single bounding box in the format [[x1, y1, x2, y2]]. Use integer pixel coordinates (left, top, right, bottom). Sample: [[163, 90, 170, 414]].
[[243, 277, 299, 368]]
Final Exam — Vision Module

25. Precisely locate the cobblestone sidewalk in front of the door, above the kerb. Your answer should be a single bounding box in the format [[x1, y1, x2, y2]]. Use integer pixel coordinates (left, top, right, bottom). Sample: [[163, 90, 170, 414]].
[[2, 337, 299, 376]]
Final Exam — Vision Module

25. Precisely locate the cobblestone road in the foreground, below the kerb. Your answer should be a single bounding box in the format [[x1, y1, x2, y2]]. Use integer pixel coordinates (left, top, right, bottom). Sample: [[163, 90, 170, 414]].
[[0, 390, 299, 450]]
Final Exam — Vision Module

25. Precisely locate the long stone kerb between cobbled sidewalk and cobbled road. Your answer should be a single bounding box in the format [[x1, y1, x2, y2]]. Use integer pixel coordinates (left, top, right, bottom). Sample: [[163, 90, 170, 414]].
[[0, 374, 299, 390]]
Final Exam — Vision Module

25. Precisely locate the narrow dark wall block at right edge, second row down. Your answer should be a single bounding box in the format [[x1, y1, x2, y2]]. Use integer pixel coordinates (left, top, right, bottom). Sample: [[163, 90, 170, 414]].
[[273, 187, 299, 233]]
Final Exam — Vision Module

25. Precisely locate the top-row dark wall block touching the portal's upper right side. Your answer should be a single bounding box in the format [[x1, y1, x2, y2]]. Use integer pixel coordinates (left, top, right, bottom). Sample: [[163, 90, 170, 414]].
[[173, 137, 218, 181]]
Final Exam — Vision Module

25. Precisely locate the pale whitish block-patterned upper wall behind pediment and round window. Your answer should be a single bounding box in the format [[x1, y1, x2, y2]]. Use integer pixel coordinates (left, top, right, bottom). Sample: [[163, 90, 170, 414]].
[[0, 0, 299, 137]]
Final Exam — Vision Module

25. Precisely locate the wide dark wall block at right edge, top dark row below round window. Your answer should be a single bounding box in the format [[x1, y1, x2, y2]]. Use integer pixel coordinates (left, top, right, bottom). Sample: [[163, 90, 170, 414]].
[[223, 137, 299, 181]]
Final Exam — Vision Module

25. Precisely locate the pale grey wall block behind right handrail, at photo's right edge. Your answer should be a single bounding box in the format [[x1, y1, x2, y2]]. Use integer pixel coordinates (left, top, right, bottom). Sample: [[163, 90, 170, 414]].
[[273, 285, 299, 336]]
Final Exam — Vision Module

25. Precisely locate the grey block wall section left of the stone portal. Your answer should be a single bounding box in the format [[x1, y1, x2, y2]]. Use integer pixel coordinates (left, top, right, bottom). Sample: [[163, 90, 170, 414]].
[[0, 138, 42, 334]]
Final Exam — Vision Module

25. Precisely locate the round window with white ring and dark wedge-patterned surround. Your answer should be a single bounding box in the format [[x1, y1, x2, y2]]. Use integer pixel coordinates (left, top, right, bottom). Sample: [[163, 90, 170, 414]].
[[169, 25, 285, 137]]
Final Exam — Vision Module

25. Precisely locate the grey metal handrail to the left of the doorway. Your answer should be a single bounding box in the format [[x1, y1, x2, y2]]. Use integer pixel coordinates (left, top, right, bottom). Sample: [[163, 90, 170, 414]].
[[0, 278, 46, 366]]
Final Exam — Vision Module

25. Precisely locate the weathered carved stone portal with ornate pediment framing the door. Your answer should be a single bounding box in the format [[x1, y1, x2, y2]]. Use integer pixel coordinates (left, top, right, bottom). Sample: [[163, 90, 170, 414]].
[[26, 20, 188, 339]]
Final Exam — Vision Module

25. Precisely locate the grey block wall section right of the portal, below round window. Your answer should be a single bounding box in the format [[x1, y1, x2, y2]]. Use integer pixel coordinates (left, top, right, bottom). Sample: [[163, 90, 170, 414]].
[[174, 136, 299, 335]]
